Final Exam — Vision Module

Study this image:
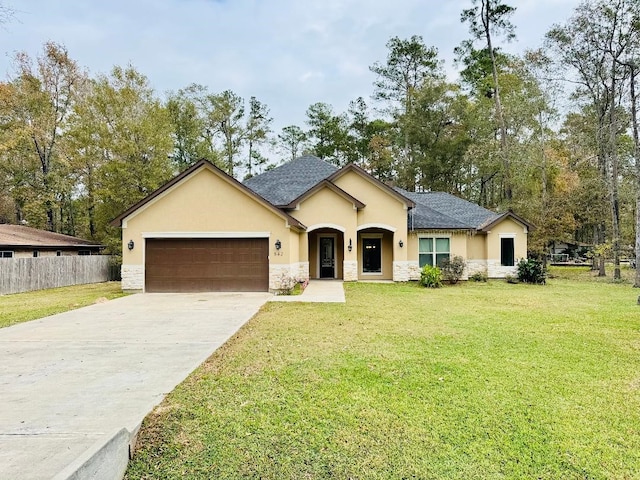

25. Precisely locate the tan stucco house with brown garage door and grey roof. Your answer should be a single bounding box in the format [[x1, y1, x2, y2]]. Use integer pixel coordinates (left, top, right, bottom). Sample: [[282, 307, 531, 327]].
[[112, 156, 530, 292]]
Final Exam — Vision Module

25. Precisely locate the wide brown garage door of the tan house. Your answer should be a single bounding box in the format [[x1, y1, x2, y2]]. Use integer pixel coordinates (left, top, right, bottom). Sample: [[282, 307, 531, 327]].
[[145, 238, 269, 292]]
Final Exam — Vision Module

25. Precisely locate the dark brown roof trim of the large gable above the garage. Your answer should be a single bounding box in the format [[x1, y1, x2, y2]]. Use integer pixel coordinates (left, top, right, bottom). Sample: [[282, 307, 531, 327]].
[[111, 159, 305, 230]]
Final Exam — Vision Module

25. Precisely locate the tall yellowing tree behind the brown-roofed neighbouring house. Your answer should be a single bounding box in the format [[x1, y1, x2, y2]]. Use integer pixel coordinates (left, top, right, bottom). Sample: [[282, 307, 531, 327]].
[[4, 42, 86, 231]]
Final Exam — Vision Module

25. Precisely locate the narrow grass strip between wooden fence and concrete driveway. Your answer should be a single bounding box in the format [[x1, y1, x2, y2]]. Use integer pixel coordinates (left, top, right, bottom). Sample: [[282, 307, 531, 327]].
[[0, 282, 124, 328]]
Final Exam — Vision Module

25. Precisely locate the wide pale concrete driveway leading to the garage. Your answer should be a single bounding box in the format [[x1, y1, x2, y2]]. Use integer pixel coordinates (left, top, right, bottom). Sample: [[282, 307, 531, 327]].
[[0, 293, 270, 479]]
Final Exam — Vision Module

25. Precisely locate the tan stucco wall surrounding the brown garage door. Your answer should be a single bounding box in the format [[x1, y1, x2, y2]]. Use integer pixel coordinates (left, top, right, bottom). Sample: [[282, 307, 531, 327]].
[[122, 167, 299, 265]]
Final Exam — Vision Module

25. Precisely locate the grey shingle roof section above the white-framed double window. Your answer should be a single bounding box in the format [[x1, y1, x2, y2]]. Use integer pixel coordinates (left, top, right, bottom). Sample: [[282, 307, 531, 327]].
[[396, 188, 500, 230]]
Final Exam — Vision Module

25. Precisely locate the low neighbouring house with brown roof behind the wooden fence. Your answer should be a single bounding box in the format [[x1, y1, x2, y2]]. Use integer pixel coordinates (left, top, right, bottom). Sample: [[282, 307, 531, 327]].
[[0, 224, 104, 258]]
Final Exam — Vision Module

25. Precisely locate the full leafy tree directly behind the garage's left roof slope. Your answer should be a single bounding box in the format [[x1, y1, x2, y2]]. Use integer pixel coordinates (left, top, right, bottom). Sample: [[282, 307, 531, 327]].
[[70, 66, 174, 253]]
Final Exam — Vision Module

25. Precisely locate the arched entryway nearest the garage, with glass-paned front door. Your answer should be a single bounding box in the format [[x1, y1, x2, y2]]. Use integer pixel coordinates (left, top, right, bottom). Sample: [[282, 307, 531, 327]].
[[307, 227, 344, 279]]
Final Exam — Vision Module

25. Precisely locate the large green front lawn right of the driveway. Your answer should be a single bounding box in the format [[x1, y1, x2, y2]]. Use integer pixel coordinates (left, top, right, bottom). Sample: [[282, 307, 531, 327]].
[[127, 279, 640, 480]]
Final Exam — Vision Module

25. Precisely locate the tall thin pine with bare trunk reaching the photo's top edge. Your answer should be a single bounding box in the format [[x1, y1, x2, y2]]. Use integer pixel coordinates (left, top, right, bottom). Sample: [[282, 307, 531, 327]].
[[458, 0, 515, 205]]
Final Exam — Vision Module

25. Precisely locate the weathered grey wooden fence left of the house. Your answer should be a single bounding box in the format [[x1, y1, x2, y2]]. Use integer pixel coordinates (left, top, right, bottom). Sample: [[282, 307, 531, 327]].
[[0, 255, 110, 295]]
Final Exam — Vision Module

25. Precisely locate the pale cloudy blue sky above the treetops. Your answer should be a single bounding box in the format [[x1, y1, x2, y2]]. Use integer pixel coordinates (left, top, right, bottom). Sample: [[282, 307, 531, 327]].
[[0, 0, 579, 133]]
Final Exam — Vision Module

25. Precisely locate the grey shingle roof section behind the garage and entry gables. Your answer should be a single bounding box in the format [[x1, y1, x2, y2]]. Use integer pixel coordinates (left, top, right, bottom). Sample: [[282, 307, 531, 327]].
[[244, 155, 338, 206]]
